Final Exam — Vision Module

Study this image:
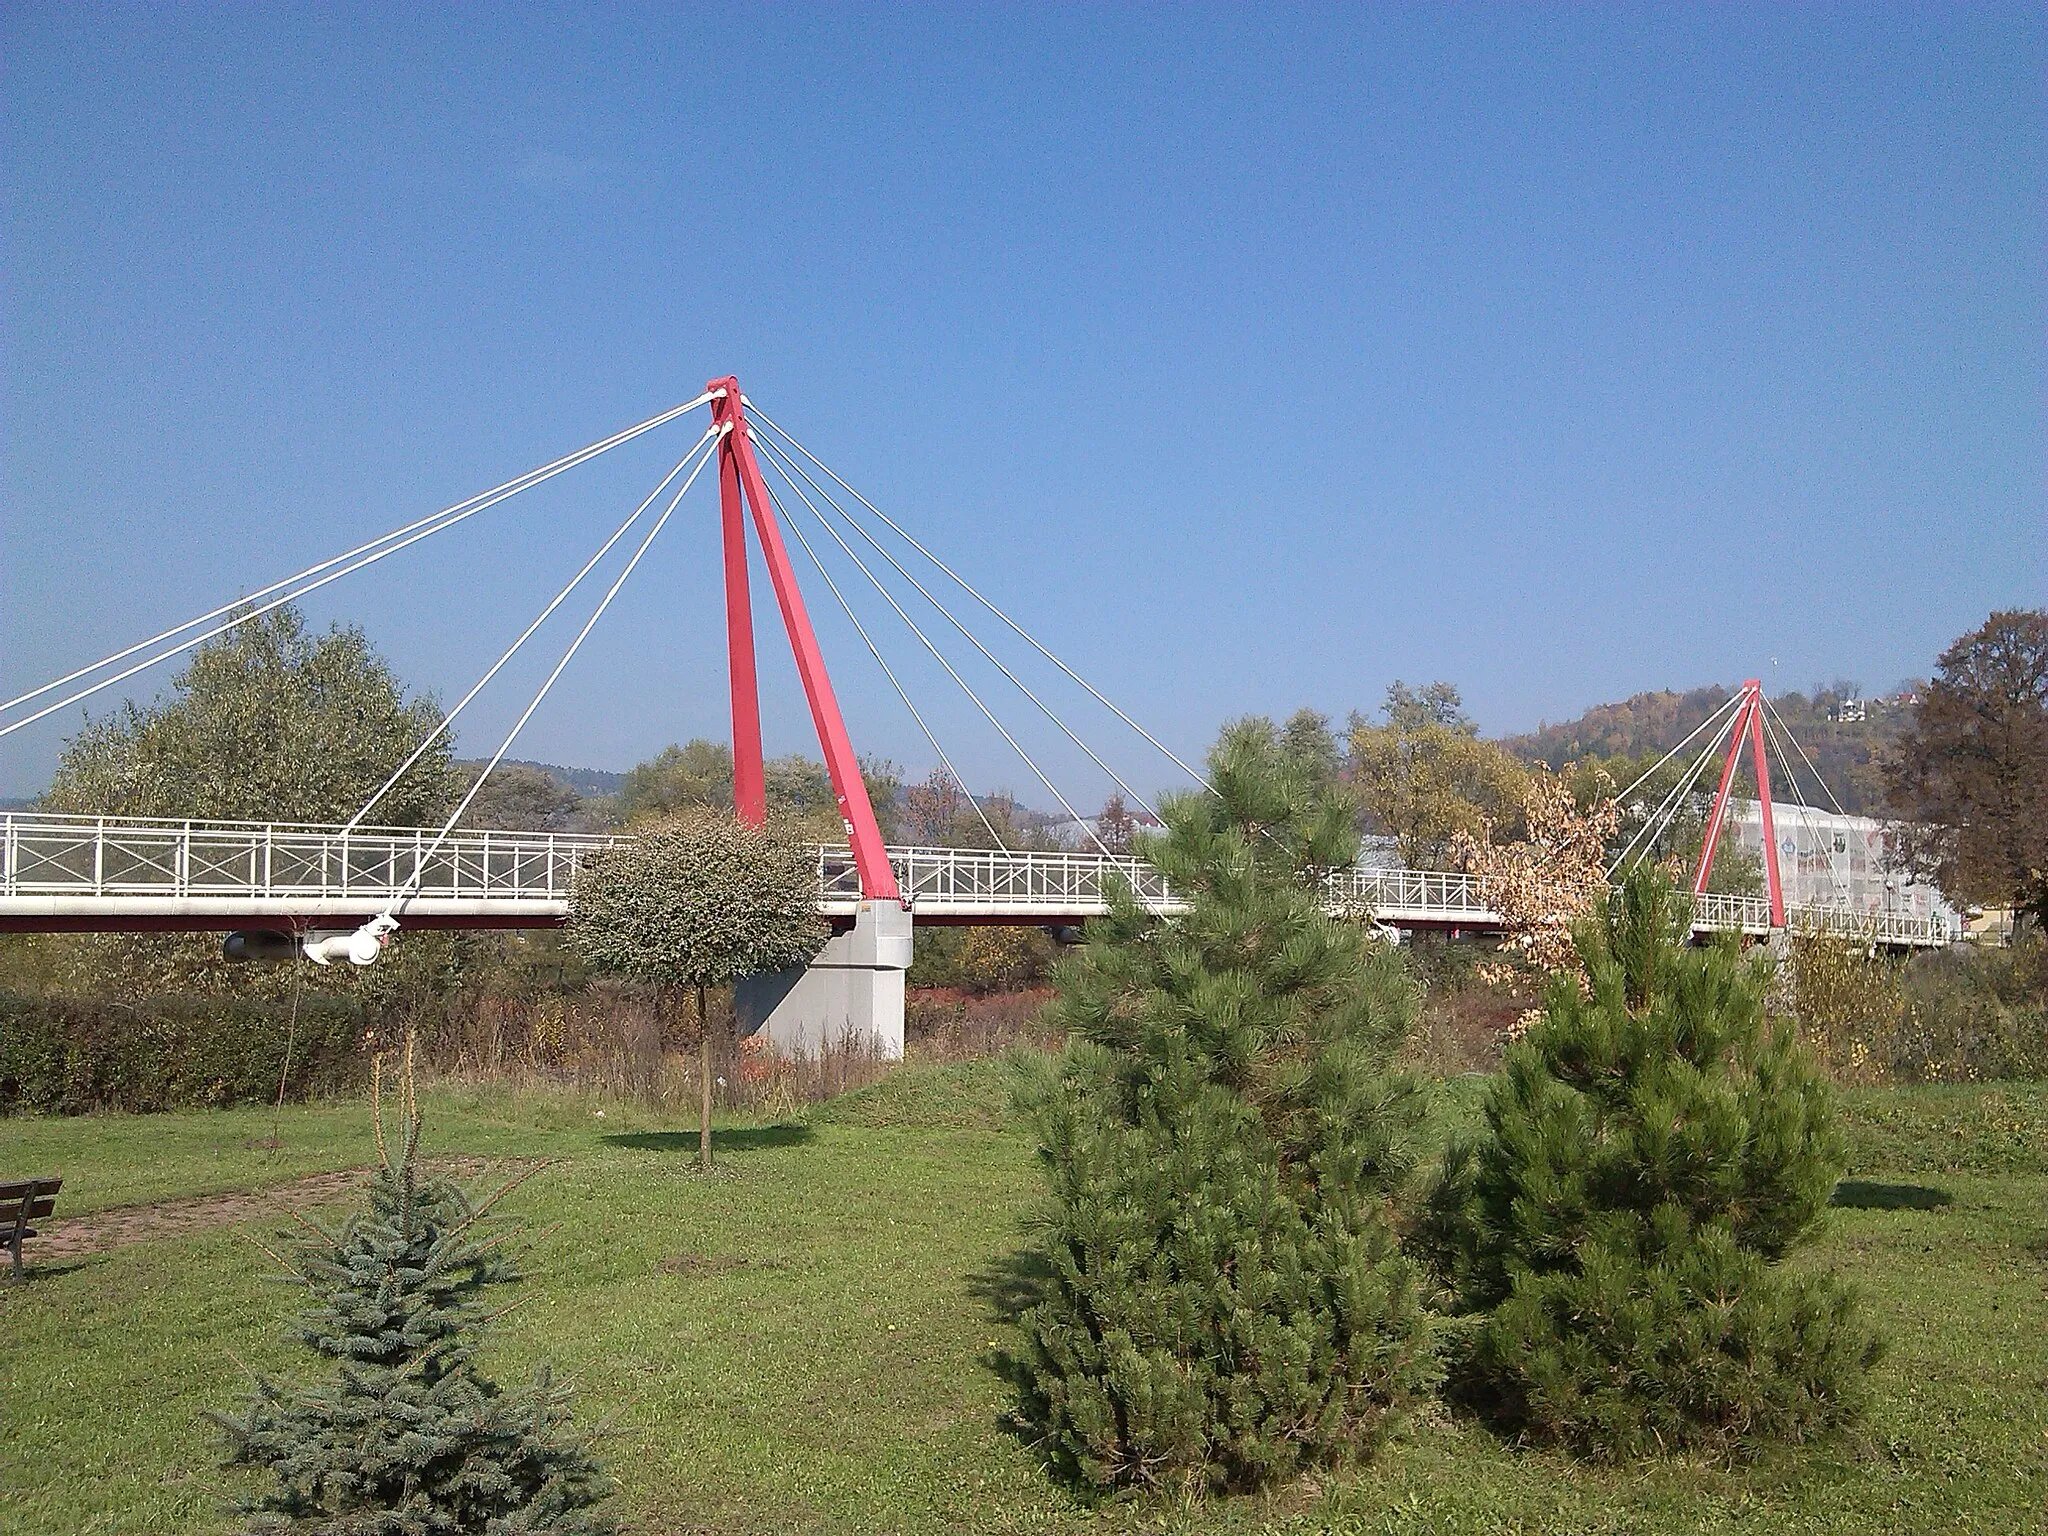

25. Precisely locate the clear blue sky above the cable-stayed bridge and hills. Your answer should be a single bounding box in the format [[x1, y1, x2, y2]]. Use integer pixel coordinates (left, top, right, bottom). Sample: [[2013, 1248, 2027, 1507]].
[[0, 4, 2048, 803]]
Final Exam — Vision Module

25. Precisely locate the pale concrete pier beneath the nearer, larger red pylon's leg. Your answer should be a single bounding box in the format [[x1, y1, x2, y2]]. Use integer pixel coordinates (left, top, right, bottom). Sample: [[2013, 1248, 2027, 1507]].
[[733, 901, 911, 1061]]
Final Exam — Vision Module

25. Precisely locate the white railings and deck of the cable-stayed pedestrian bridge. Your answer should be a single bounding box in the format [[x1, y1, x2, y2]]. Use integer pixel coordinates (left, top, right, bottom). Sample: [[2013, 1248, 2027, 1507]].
[[0, 811, 1954, 948]]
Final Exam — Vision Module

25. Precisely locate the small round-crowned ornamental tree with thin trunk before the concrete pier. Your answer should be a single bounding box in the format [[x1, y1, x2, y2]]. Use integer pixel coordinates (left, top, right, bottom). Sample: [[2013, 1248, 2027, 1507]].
[[569, 811, 831, 1169]]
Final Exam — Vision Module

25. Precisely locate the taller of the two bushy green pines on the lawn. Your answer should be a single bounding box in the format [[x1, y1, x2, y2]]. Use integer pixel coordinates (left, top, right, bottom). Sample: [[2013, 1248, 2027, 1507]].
[[1012, 721, 1434, 1489]]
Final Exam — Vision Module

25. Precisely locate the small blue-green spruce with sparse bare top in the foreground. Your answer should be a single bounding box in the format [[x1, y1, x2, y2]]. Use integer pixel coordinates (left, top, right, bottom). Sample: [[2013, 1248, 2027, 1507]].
[[209, 1071, 618, 1536]]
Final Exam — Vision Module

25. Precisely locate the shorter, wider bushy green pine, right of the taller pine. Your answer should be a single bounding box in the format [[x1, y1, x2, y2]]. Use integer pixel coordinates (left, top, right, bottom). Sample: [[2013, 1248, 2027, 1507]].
[[1421, 870, 1878, 1458]]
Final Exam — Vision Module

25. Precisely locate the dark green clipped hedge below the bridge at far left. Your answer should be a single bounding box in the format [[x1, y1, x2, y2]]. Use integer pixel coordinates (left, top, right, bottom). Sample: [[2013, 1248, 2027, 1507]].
[[0, 991, 369, 1114]]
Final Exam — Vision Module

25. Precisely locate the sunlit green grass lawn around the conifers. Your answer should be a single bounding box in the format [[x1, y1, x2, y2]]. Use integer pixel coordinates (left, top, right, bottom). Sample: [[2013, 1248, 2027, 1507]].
[[0, 1065, 2048, 1536]]
